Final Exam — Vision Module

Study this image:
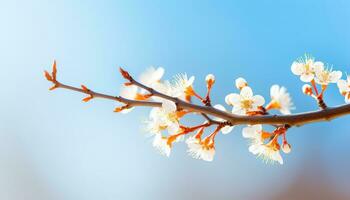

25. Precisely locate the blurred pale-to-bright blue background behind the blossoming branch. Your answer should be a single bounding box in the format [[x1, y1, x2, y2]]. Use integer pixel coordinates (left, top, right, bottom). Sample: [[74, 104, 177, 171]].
[[0, 0, 350, 200]]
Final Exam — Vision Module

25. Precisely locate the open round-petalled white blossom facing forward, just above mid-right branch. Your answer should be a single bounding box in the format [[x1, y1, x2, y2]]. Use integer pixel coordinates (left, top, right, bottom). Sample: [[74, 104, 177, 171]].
[[225, 86, 265, 115]]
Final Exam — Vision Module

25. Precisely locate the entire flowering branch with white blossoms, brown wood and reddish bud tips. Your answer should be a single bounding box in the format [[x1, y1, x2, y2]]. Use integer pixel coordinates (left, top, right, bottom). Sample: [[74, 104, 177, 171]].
[[45, 56, 350, 164]]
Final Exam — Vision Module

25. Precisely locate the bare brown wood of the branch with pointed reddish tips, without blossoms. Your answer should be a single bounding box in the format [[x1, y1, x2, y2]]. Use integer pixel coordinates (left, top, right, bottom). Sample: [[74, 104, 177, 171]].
[[45, 64, 350, 126]]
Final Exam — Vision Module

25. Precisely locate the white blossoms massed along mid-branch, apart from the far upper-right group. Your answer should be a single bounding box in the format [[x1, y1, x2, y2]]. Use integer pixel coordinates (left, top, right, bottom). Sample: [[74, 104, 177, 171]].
[[118, 67, 294, 164]]
